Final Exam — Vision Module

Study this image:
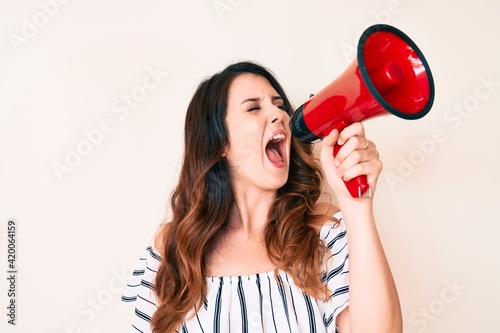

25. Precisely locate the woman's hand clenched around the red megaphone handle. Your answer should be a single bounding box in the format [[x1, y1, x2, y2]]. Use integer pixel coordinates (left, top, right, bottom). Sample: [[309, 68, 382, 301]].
[[320, 123, 382, 200]]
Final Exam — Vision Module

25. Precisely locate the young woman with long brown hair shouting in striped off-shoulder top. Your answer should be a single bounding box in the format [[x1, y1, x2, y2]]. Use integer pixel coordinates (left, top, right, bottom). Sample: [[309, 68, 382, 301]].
[[122, 62, 402, 333]]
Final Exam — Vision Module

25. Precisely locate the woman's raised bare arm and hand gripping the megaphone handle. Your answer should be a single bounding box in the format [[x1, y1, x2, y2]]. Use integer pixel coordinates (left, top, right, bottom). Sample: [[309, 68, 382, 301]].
[[320, 123, 402, 333]]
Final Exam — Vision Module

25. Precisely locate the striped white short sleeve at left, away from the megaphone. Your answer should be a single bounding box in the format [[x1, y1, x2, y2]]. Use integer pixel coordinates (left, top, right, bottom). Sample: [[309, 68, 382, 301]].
[[122, 246, 161, 333]]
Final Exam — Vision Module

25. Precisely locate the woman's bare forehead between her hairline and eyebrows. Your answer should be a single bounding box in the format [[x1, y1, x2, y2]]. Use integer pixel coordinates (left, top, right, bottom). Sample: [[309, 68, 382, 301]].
[[229, 73, 279, 101]]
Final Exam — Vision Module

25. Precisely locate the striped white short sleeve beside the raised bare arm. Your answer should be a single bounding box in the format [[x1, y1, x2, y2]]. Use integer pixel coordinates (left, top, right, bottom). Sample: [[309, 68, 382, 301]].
[[320, 212, 349, 332]]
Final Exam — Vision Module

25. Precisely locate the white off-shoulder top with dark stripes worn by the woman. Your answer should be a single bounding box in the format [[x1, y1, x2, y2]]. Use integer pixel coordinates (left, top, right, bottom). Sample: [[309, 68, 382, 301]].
[[122, 212, 349, 333]]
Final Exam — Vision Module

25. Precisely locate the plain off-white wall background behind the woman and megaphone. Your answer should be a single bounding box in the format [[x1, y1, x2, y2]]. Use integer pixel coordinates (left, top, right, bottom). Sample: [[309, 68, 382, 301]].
[[0, 0, 500, 333]]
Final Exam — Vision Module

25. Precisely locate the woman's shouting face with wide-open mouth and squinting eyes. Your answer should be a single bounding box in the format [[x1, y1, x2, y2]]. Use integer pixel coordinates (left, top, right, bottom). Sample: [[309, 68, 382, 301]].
[[226, 73, 291, 190]]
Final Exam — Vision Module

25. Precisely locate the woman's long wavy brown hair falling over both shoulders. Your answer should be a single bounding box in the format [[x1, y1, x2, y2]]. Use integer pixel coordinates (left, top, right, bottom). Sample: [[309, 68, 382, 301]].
[[151, 62, 327, 332]]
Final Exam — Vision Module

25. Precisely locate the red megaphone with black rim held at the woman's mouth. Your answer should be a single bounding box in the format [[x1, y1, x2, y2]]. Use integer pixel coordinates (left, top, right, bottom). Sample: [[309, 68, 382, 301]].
[[290, 24, 434, 197]]
